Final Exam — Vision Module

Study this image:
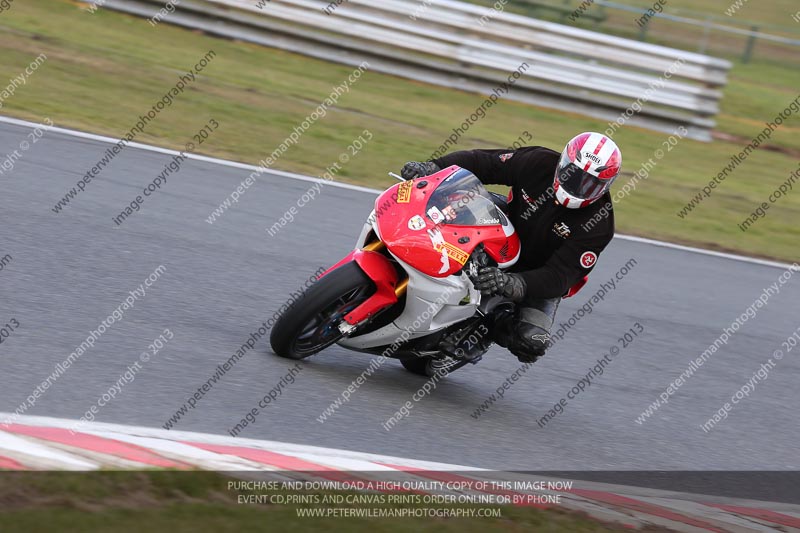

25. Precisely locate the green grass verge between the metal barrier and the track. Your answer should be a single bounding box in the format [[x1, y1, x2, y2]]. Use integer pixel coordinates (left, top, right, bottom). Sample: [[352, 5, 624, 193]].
[[0, 0, 800, 260]]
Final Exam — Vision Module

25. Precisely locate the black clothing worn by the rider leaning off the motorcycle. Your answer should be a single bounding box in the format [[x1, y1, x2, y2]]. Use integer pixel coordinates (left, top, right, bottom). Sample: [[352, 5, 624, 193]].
[[433, 146, 614, 361]]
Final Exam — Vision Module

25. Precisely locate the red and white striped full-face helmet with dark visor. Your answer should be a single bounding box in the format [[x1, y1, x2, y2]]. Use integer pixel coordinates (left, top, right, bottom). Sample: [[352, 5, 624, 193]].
[[553, 132, 622, 209]]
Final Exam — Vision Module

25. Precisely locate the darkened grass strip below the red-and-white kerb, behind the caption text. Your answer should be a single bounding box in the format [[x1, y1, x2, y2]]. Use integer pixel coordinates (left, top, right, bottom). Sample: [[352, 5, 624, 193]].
[[0, 471, 644, 533]]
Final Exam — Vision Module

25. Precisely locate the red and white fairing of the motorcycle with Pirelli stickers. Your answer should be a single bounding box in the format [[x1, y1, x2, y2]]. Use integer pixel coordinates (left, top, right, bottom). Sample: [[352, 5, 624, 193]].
[[334, 166, 521, 350]]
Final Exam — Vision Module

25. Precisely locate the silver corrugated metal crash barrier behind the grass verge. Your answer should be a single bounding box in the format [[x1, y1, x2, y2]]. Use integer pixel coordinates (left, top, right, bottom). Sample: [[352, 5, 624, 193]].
[[105, 0, 731, 140]]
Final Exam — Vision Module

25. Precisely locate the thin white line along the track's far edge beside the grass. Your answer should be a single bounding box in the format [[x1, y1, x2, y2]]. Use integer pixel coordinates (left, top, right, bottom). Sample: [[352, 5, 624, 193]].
[[0, 116, 791, 270]]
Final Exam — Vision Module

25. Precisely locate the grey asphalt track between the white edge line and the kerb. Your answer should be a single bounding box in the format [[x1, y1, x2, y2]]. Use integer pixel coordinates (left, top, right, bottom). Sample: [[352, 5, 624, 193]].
[[0, 124, 800, 482]]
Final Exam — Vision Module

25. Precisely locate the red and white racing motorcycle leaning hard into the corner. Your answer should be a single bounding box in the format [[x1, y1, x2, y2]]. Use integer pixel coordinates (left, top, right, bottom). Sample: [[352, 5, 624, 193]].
[[270, 166, 520, 376]]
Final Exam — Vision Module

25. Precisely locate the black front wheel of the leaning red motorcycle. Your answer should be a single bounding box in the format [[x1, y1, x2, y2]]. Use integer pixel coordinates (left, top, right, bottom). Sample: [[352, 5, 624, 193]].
[[269, 262, 375, 359]]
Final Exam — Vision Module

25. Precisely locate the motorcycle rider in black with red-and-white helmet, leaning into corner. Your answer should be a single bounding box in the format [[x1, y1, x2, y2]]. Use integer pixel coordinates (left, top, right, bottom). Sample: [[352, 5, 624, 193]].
[[400, 132, 622, 363]]
